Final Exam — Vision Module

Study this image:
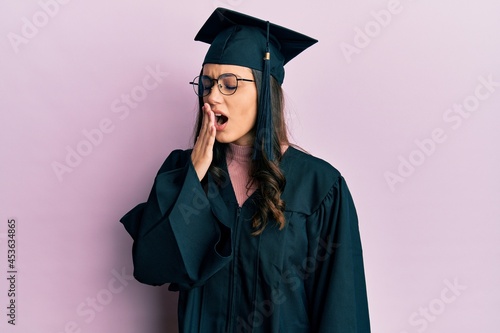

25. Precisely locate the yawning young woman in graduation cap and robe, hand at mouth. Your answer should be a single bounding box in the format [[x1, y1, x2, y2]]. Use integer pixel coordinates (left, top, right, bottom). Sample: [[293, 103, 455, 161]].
[[121, 8, 370, 333]]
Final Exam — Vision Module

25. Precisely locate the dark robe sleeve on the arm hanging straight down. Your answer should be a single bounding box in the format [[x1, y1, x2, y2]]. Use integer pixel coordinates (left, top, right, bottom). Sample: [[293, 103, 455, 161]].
[[306, 176, 370, 333]]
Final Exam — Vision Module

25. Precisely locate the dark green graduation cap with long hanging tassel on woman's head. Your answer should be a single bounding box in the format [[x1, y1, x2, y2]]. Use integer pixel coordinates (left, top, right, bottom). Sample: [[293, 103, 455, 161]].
[[194, 7, 317, 160]]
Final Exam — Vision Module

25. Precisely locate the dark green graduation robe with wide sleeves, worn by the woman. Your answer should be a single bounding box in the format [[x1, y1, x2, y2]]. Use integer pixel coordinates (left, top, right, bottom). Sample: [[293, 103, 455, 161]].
[[121, 147, 370, 333]]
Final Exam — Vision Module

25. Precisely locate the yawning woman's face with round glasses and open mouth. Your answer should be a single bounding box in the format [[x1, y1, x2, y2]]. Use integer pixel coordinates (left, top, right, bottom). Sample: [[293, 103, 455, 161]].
[[203, 64, 257, 146]]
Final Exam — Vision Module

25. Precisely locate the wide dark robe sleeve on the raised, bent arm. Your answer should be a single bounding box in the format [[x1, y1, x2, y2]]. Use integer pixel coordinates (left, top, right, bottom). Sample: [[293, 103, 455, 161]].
[[120, 150, 232, 290]]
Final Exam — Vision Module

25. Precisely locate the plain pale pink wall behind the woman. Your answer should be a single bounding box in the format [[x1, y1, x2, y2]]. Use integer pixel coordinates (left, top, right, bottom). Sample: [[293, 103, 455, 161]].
[[0, 0, 500, 333]]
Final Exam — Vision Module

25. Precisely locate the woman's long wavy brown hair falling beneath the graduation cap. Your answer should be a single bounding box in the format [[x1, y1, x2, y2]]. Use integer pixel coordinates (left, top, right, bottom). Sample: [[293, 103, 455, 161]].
[[194, 70, 290, 236]]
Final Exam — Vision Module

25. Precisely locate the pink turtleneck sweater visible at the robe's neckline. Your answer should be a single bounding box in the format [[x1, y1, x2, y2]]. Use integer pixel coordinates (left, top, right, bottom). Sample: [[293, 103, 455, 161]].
[[226, 143, 257, 207]]
